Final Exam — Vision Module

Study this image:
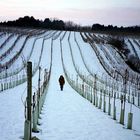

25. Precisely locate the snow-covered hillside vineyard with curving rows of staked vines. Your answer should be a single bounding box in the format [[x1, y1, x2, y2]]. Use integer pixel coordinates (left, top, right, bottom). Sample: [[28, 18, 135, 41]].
[[0, 27, 140, 140]]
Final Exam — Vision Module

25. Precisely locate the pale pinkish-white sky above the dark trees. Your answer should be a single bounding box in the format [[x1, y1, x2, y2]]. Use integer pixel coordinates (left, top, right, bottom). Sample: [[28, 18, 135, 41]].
[[0, 0, 140, 26]]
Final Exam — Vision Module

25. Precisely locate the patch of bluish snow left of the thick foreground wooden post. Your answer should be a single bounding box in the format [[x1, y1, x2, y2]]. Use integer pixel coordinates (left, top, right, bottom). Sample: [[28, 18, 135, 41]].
[[0, 83, 26, 140]]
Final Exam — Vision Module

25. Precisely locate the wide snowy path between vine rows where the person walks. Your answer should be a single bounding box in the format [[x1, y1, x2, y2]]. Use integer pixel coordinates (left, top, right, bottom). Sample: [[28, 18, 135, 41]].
[[35, 36, 139, 140]]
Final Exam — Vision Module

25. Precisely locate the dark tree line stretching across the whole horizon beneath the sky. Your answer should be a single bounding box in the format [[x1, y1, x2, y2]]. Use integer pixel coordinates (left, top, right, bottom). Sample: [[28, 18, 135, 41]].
[[0, 16, 140, 33]]
